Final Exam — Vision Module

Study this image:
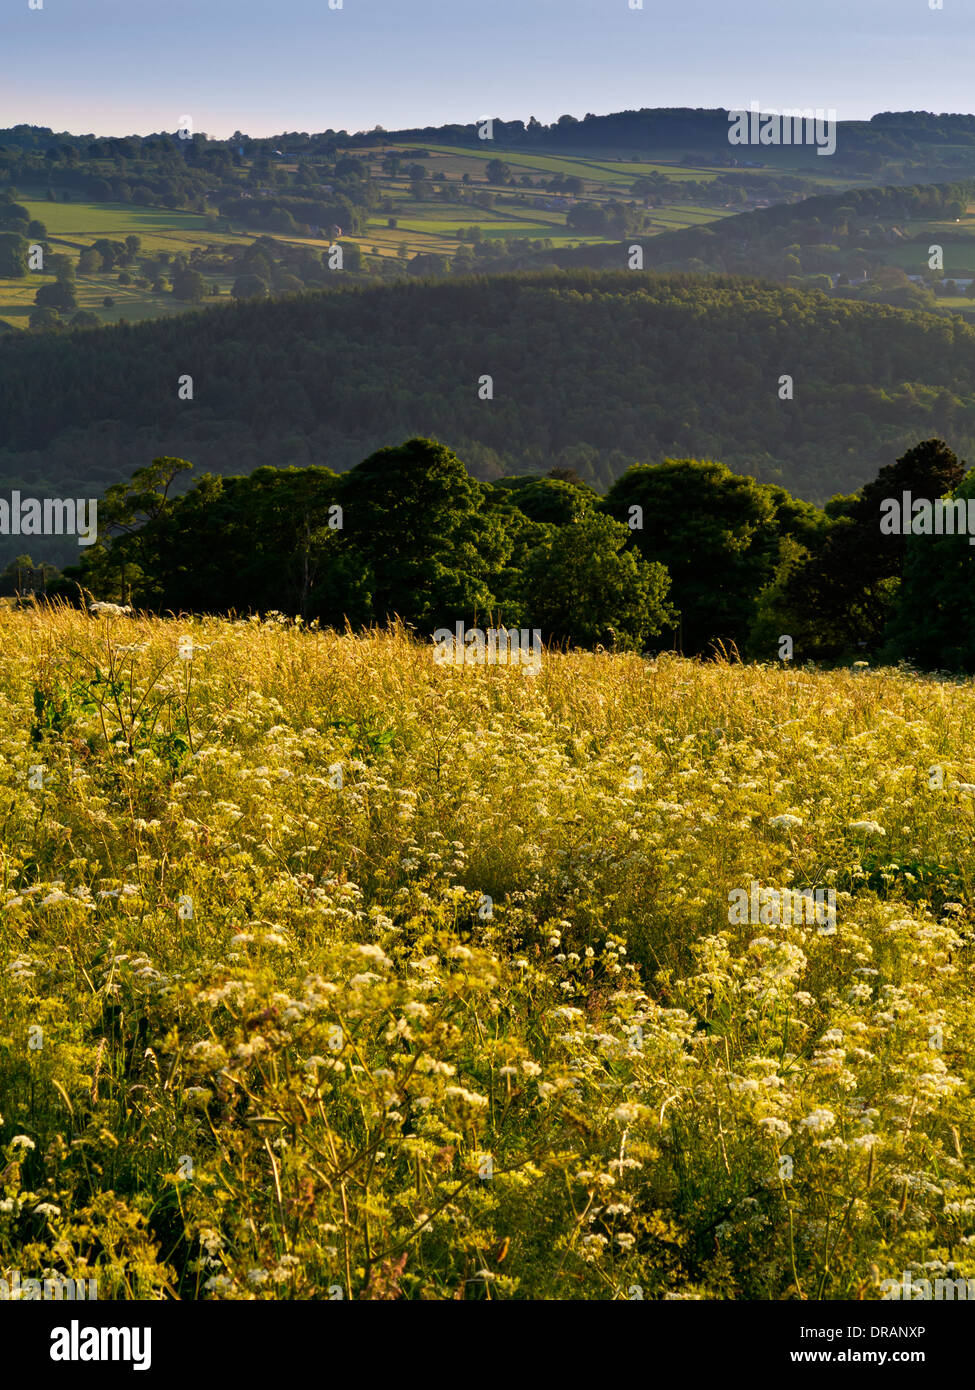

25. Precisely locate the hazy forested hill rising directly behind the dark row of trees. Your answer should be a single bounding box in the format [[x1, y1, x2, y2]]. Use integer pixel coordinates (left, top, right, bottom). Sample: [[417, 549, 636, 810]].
[[0, 271, 975, 544]]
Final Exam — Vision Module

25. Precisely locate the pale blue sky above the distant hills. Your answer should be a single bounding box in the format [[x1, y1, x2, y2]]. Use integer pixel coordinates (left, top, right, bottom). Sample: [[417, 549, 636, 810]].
[[0, 0, 975, 138]]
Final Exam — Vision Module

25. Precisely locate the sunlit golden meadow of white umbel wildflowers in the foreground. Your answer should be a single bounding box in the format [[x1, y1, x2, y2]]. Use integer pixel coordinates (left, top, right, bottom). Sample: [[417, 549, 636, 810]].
[[0, 607, 975, 1300]]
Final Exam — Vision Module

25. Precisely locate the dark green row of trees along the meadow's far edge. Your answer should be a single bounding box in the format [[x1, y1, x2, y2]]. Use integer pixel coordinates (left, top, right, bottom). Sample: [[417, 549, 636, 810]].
[[0, 438, 975, 671]]
